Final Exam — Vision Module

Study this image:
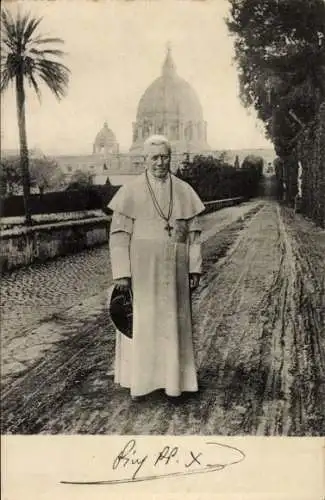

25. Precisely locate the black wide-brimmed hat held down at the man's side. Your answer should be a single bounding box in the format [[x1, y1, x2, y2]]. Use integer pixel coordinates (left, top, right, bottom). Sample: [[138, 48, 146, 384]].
[[107, 285, 133, 339]]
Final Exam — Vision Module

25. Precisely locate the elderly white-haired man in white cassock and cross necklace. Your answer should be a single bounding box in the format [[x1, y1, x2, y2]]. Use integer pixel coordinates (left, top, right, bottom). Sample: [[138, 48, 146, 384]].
[[109, 136, 204, 399]]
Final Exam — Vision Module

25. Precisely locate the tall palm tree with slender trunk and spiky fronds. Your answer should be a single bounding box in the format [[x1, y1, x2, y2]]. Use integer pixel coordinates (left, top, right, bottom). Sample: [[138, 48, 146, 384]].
[[1, 10, 70, 225]]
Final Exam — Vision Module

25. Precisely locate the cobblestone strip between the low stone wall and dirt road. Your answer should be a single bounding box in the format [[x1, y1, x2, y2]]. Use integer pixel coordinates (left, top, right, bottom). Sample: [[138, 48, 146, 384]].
[[1, 245, 111, 346]]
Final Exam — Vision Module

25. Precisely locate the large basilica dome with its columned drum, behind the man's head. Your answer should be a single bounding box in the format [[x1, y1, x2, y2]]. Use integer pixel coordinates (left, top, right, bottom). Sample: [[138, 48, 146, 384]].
[[130, 48, 209, 154]]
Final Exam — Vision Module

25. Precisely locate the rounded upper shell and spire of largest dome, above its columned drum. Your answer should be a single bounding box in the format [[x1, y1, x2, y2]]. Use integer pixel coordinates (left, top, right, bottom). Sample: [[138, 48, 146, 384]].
[[136, 48, 203, 122]]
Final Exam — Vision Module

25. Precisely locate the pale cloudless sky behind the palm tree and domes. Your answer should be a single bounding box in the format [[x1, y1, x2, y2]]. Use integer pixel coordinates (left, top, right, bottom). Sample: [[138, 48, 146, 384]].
[[1, 0, 272, 154]]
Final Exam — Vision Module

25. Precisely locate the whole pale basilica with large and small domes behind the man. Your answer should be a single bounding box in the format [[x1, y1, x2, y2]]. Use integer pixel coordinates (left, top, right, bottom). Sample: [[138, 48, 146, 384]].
[[57, 47, 210, 175]]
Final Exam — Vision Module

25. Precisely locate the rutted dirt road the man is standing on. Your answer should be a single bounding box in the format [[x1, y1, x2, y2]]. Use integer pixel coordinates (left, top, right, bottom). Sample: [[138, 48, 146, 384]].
[[2, 201, 325, 436]]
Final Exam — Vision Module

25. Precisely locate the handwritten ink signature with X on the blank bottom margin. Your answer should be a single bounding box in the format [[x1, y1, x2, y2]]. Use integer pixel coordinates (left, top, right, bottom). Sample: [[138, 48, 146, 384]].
[[61, 439, 246, 485]]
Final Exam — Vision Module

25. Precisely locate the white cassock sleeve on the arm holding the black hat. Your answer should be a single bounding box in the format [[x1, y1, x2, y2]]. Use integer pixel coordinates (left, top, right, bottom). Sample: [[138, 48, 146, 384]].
[[109, 212, 133, 279]]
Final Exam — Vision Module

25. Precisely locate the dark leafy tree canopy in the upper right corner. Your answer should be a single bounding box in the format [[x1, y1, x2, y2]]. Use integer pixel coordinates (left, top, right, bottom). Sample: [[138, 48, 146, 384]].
[[227, 0, 325, 155]]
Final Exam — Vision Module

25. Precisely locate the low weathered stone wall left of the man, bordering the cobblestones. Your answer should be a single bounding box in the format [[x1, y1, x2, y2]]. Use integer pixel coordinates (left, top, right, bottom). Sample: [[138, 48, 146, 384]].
[[0, 216, 110, 272]]
